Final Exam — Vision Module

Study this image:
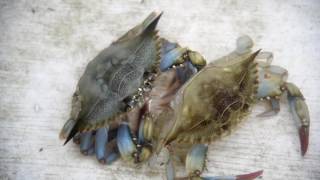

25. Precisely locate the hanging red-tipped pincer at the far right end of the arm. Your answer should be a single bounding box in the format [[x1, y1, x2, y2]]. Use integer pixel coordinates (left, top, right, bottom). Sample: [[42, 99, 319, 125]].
[[285, 83, 310, 155]]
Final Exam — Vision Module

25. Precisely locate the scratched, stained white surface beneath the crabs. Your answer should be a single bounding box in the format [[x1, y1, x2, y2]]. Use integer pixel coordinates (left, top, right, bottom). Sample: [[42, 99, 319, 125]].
[[0, 0, 320, 180]]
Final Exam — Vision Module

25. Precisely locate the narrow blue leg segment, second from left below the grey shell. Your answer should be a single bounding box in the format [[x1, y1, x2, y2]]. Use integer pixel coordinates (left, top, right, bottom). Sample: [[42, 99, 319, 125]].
[[95, 127, 109, 163]]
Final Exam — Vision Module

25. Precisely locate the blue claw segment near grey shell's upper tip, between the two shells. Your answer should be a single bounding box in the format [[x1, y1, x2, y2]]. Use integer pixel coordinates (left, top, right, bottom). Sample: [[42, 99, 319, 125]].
[[160, 47, 187, 71]]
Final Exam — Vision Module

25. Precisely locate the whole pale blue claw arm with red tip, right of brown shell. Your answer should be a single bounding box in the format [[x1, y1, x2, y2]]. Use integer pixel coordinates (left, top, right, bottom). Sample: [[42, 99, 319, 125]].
[[256, 52, 310, 155]]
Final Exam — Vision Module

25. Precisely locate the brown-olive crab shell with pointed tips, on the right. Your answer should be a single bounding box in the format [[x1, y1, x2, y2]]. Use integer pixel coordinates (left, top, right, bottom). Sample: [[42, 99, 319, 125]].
[[161, 51, 259, 145]]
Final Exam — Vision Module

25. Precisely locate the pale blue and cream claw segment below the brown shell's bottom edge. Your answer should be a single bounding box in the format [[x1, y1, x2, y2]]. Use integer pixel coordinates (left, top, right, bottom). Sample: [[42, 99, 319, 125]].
[[186, 144, 208, 177]]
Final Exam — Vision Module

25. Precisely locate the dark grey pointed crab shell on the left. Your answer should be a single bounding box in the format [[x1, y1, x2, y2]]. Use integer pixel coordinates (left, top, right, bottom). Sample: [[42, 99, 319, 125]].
[[61, 13, 161, 142]]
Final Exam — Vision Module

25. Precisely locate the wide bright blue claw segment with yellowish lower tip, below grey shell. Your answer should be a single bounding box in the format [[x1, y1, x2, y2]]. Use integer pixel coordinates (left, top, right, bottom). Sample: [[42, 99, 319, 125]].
[[117, 123, 138, 161]]
